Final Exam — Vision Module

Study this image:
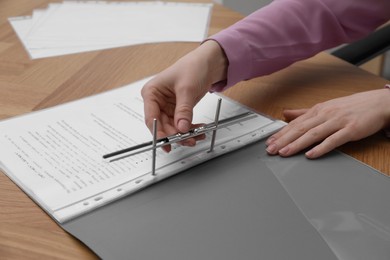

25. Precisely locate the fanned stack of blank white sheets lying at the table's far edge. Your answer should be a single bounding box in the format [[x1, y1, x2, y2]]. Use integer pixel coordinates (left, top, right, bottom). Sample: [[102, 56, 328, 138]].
[[9, 1, 212, 59]]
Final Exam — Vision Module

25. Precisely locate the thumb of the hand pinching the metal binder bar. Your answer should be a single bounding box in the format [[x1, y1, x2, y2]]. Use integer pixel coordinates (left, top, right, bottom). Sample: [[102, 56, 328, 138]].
[[175, 96, 196, 133]]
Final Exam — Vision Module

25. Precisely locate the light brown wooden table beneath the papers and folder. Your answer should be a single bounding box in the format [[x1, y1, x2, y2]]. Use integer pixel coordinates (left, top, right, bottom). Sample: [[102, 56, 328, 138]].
[[0, 0, 390, 259]]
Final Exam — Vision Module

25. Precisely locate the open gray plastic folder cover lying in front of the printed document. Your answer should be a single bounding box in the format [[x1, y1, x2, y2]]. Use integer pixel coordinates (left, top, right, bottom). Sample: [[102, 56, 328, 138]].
[[62, 142, 390, 260]]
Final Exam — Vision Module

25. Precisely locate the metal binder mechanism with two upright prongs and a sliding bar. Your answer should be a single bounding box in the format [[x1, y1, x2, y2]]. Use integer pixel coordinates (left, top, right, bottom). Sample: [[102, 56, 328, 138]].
[[103, 98, 256, 176]]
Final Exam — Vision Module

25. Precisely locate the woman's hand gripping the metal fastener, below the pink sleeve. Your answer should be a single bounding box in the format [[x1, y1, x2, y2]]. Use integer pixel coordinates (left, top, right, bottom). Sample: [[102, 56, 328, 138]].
[[142, 40, 228, 152]]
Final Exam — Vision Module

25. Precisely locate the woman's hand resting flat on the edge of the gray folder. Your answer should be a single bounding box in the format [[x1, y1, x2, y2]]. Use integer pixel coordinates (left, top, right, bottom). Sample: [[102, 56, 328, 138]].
[[266, 89, 390, 159]]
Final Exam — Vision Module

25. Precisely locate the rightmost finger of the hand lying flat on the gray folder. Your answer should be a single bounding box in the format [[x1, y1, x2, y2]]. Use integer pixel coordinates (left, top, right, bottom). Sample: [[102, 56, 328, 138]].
[[305, 128, 351, 159]]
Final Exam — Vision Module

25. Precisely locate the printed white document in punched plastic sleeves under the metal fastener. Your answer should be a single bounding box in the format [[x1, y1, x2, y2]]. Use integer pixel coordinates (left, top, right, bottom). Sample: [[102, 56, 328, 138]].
[[0, 77, 284, 222]]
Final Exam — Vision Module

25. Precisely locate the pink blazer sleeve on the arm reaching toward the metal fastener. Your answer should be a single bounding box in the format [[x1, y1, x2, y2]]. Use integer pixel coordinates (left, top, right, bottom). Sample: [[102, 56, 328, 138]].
[[209, 0, 390, 91]]
